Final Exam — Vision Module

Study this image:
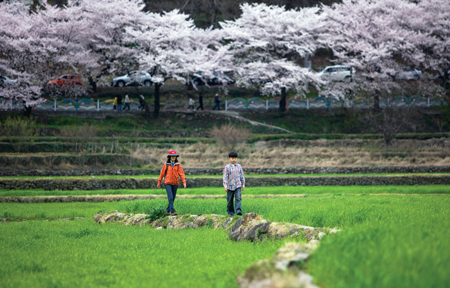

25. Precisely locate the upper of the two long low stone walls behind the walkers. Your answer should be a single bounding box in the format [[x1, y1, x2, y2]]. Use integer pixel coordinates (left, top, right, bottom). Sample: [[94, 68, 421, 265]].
[[0, 165, 450, 177]]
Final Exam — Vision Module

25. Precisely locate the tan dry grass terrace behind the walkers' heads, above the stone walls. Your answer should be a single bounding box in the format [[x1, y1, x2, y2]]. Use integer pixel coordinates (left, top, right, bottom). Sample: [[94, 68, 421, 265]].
[[125, 140, 450, 168]]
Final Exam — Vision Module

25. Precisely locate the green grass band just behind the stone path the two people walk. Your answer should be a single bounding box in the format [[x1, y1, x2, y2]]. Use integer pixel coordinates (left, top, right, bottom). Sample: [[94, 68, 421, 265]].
[[0, 195, 450, 228]]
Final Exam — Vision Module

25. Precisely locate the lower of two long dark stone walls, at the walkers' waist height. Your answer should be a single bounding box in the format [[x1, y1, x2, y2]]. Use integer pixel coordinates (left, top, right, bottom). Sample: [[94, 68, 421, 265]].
[[0, 175, 450, 190]]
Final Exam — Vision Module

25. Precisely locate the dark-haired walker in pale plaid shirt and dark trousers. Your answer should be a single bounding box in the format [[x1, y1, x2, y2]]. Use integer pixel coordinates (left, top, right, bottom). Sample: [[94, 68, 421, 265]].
[[223, 152, 245, 217]]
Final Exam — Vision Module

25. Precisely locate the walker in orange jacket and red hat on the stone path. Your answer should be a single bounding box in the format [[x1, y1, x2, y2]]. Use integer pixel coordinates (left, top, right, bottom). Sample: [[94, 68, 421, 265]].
[[158, 150, 186, 215]]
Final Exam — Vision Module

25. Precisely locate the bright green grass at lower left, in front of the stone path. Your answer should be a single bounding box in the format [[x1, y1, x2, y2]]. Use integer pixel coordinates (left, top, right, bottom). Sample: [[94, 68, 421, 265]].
[[0, 220, 288, 288]]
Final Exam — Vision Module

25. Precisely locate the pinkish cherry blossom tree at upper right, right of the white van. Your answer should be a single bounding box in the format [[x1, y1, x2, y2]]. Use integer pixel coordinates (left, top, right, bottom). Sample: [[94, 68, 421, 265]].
[[322, 0, 446, 110]]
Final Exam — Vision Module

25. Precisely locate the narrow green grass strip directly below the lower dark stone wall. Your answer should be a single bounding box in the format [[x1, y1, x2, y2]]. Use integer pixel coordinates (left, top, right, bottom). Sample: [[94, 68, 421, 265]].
[[0, 185, 450, 197]]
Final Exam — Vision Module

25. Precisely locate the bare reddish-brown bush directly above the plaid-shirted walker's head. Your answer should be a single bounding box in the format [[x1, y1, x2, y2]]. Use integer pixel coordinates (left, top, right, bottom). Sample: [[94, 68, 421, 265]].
[[211, 124, 251, 151]]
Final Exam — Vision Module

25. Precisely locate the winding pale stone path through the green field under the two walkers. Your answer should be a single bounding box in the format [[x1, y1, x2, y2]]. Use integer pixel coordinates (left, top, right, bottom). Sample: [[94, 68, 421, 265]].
[[93, 211, 330, 288]]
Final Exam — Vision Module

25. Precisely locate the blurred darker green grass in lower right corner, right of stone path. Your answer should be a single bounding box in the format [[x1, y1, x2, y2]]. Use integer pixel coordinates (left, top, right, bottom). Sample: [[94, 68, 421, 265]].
[[308, 198, 450, 288]]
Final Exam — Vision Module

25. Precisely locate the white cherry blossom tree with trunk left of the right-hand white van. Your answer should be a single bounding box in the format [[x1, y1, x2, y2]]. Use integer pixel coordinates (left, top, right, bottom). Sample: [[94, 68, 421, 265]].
[[221, 4, 325, 111]]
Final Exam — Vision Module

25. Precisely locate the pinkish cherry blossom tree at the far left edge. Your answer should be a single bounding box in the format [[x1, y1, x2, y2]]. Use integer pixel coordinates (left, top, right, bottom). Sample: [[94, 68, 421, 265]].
[[0, 2, 91, 115]]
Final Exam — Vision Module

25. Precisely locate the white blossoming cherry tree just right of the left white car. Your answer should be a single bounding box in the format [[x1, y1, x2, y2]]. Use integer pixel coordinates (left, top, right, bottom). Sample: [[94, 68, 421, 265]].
[[127, 10, 229, 117]]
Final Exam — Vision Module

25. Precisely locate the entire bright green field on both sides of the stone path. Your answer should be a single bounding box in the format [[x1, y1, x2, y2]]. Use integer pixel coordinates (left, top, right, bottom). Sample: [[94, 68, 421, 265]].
[[0, 194, 450, 287]]
